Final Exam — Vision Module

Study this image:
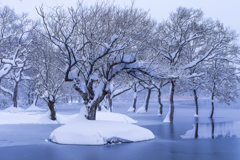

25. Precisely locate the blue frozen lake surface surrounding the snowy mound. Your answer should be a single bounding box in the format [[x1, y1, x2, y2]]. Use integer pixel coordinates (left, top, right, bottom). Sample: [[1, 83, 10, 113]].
[[0, 100, 240, 160]]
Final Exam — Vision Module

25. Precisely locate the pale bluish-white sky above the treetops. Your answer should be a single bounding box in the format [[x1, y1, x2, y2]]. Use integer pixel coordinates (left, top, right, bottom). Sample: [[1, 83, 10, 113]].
[[0, 0, 240, 34]]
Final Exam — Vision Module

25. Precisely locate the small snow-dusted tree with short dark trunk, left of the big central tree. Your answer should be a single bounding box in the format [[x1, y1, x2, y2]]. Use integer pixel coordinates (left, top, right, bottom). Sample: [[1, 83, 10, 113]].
[[31, 36, 65, 120]]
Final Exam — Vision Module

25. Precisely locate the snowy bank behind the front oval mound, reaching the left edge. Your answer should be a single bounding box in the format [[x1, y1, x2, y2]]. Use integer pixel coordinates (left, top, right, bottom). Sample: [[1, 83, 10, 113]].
[[0, 106, 137, 124]]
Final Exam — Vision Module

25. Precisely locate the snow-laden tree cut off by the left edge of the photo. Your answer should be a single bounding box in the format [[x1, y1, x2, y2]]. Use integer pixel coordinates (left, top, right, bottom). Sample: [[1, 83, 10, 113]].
[[0, 7, 34, 107]]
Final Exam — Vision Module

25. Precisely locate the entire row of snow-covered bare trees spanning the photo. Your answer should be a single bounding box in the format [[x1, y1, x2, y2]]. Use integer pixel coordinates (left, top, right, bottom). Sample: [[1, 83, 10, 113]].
[[0, 2, 239, 123]]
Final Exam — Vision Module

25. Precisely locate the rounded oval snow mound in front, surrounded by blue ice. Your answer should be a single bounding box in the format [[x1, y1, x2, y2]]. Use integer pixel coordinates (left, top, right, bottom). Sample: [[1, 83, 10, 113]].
[[49, 120, 155, 145]]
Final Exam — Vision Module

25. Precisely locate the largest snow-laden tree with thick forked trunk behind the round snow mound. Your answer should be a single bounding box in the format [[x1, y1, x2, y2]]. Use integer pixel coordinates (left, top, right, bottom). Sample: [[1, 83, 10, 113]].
[[38, 3, 154, 120]]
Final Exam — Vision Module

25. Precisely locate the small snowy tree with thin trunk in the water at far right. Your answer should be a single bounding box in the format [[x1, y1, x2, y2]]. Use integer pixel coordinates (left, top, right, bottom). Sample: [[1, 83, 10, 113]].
[[206, 58, 239, 118]]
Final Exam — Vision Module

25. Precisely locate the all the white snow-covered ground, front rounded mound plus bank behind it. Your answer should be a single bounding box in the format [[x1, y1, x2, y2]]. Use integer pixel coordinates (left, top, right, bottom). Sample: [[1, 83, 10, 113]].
[[0, 103, 155, 145]]
